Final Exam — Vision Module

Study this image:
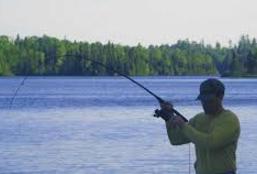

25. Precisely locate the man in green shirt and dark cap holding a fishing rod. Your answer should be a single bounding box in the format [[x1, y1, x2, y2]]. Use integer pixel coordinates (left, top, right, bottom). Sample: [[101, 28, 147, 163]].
[[157, 78, 240, 174]]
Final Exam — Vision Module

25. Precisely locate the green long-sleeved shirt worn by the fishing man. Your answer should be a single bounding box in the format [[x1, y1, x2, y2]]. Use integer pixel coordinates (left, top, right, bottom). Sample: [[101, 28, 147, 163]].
[[166, 110, 240, 174]]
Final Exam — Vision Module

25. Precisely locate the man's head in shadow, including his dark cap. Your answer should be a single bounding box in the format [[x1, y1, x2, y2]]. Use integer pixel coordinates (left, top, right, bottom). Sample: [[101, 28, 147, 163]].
[[197, 78, 225, 115]]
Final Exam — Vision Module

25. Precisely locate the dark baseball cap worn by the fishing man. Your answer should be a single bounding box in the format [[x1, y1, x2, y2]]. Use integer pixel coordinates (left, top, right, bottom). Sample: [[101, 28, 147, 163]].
[[196, 78, 225, 100]]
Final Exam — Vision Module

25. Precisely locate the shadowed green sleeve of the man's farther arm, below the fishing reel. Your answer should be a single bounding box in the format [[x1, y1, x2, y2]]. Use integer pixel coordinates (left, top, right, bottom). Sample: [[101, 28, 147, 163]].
[[166, 119, 193, 145]]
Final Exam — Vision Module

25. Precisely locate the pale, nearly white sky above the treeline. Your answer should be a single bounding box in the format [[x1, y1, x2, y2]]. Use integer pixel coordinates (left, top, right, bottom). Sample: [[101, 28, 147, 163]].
[[0, 0, 257, 46]]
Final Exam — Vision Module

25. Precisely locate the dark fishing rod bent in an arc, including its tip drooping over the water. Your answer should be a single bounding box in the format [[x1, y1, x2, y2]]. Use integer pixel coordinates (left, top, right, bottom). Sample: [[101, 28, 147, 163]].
[[9, 54, 188, 122]]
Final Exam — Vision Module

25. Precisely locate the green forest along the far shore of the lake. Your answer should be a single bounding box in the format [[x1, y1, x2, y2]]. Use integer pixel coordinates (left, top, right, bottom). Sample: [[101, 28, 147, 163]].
[[0, 35, 257, 76]]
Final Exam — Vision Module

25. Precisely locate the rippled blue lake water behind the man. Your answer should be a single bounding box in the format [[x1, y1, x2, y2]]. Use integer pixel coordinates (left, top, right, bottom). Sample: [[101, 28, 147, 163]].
[[0, 77, 257, 174]]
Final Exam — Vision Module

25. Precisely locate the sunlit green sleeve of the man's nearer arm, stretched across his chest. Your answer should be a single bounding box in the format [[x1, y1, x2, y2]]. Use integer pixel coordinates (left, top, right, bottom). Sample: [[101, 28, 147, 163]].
[[182, 116, 240, 148]]
